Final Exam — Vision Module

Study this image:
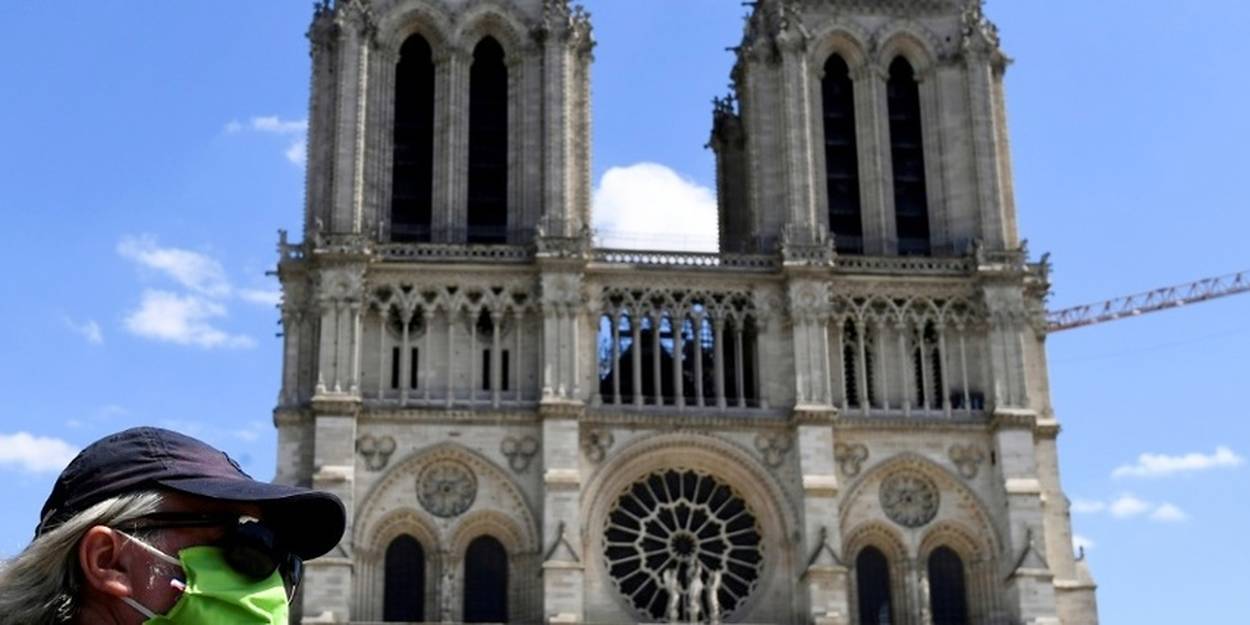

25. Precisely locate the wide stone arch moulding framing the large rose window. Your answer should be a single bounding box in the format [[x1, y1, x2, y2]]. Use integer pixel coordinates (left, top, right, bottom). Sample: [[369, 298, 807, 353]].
[[581, 433, 803, 623]]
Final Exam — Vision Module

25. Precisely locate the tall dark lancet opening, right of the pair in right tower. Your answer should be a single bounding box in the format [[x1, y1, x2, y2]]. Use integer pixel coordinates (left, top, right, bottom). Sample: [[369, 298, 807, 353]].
[[888, 56, 930, 255]]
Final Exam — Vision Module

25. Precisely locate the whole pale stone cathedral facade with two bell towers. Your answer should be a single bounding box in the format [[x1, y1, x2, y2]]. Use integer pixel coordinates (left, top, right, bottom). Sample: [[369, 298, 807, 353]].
[[274, 0, 1098, 625]]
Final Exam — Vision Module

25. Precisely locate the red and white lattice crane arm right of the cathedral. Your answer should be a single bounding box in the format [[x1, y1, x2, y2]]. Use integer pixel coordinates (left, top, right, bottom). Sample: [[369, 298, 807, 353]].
[[1046, 270, 1250, 333]]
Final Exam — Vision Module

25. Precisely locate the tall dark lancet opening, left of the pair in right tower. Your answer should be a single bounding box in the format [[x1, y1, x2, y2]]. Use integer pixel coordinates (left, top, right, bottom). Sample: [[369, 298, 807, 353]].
[[821, 54, 864, 254]]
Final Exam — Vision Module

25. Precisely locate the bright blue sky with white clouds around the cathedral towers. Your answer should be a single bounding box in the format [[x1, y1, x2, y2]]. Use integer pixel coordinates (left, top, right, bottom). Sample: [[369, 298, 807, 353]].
[[0, 0, 1250, 624]]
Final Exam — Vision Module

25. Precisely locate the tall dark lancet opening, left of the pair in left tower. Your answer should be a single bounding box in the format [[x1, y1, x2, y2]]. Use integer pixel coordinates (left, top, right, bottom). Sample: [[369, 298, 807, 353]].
[[391, 35, 434, 243]]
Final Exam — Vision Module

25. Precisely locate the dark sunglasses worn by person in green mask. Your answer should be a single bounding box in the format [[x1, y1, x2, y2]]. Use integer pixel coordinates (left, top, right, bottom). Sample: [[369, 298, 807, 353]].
[[119, 513, 304, 603]]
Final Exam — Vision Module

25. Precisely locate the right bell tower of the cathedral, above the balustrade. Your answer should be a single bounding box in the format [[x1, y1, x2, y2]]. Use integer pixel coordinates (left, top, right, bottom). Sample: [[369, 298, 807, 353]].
[[711, 0, 1019, 256]]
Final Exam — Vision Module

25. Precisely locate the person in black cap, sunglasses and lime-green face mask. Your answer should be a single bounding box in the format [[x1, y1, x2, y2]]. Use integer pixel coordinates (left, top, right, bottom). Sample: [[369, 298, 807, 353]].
[[0, 428, 346, 625]]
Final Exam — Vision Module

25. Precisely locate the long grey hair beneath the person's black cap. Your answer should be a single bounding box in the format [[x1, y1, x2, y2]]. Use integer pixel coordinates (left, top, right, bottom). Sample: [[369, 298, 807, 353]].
[[0, 491, 161, 625]]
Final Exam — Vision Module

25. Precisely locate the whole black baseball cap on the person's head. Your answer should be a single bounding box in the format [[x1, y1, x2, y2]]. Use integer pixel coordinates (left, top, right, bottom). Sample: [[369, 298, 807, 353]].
[[35, 428, 346, 560]]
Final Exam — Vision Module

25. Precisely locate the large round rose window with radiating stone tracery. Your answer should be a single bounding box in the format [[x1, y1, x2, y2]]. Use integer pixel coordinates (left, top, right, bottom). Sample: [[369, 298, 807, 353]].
[[604, 469, 764, 621]]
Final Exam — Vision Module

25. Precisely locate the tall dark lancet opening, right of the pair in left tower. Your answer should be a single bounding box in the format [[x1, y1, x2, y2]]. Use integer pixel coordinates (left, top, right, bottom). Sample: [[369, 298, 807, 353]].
[[466, 38, 508, 244]]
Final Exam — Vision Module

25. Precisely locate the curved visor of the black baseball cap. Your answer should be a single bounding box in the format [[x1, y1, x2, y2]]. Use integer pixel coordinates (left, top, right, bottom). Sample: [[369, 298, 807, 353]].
[[159, 478, 348, 560]]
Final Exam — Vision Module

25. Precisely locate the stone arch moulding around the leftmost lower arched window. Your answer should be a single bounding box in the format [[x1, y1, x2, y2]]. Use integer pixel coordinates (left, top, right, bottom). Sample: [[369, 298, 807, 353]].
[[353, 508, 443, 621]]
